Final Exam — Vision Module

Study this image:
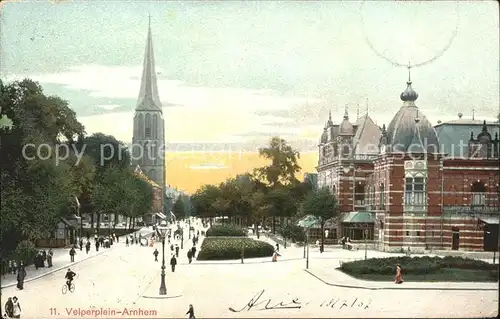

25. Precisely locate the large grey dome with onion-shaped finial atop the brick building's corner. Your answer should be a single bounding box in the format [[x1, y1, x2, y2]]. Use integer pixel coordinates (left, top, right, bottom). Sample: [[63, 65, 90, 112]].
[[387, 70, 439, 153]]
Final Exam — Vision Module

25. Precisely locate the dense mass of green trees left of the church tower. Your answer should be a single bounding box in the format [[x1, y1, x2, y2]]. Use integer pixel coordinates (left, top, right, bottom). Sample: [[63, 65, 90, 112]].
[[0, 79, 153, 253]]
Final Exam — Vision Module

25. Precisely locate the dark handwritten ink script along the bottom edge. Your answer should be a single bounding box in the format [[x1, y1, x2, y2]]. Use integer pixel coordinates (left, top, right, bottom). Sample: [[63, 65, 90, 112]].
[[229, 289, 371, 312]]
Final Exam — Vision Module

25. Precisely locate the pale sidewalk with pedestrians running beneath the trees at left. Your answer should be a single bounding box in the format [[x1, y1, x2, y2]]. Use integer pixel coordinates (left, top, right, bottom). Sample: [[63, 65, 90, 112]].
[[1, 228, 153, 289]]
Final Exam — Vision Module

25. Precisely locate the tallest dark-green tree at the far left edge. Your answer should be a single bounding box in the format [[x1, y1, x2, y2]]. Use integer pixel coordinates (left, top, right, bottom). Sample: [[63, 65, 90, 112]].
[[0, 79, 84, 245]]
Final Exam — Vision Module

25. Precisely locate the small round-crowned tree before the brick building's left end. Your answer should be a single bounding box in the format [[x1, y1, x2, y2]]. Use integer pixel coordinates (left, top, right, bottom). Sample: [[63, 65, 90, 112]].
[[302, 188, 339, 252]]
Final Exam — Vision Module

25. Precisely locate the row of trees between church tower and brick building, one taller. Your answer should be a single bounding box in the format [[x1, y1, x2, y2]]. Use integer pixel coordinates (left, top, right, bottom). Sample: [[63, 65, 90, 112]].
[[191, 137, 338, 252]]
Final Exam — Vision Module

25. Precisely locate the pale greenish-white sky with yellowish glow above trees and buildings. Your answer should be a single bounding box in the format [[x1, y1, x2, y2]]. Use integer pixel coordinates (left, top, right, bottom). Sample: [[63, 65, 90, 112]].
[[0, 0, 500, 189]]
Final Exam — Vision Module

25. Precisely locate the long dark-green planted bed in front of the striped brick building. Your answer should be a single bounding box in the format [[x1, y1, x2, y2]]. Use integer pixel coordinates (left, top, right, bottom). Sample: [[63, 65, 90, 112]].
[[340, 256, 498, 281]]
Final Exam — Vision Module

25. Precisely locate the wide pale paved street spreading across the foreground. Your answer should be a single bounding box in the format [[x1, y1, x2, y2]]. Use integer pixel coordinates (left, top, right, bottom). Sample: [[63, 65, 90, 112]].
[[2, 226, 498, 318]]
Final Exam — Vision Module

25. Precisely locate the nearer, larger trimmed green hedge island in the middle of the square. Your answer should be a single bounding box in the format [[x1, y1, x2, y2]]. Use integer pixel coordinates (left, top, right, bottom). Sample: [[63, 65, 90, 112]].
[[197, 237, 274, 260]]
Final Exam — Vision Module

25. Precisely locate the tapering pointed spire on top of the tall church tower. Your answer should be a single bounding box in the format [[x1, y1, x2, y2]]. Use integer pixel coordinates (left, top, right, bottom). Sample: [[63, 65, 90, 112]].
[[136, 16, 162, 112]]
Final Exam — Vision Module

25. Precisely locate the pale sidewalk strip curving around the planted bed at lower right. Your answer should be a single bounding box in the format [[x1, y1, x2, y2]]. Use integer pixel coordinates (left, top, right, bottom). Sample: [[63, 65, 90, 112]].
[[306, 267, 498, 291]]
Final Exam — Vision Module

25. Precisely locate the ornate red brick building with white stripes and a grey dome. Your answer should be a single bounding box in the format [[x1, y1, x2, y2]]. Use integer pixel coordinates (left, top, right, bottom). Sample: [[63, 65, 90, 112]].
[[317, 74, 500, 251]]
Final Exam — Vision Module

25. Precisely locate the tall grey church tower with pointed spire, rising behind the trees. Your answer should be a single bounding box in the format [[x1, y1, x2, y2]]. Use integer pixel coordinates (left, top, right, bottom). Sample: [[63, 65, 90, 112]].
[[131, 17, 165, 207]]
